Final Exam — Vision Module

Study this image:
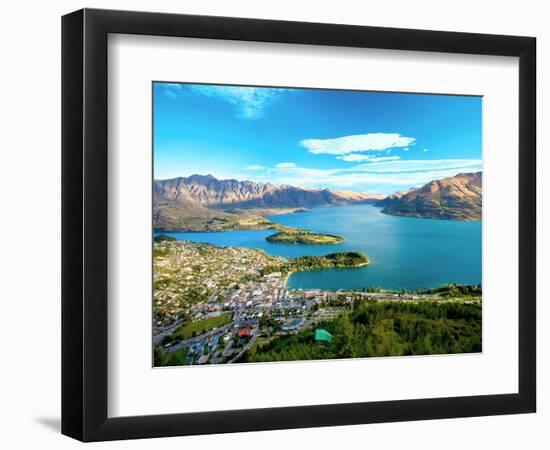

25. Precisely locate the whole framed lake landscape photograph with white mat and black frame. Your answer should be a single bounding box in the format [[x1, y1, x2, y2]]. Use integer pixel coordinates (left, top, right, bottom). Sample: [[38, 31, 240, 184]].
[[62, 9, 536, 441]]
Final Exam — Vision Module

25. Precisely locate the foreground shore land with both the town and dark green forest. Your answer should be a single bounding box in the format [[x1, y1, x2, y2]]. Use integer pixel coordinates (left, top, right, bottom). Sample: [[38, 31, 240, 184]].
[[153, 236, 481, 366]]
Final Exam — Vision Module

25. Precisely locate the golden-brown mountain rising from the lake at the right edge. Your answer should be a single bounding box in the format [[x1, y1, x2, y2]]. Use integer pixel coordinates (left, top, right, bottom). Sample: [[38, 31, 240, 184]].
[[376, 172, 482, 220]]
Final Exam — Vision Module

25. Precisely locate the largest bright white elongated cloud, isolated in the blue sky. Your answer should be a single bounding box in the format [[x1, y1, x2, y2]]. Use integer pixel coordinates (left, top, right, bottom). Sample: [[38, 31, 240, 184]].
[[300, 133, 415, 155]]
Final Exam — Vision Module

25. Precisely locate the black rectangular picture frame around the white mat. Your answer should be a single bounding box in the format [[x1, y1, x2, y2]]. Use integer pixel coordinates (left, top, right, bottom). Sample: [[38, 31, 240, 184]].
[[62, 9, 536, 441]]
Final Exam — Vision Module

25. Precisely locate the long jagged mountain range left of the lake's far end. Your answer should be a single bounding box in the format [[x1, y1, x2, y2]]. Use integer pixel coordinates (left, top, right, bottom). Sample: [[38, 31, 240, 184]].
[[153, 175, 384, 230]]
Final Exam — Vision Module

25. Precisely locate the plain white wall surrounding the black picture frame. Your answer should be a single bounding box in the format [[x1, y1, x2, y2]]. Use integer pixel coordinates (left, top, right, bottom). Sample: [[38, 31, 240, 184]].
[[0, 0, 550, 450]]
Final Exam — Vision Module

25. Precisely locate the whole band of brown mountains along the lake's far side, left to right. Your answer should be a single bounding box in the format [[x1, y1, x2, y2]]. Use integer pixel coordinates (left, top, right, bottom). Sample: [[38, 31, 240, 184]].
[[153, 172, 482, 231]]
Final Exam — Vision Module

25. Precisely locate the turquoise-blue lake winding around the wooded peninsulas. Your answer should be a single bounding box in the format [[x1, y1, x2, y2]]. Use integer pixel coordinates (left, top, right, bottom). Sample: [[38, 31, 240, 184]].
[[158, 205, 481, 290]]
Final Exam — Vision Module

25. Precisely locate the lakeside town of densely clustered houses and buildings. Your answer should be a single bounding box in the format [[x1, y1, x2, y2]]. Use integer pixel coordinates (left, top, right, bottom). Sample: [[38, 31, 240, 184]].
[[153, 238, 480, 365]]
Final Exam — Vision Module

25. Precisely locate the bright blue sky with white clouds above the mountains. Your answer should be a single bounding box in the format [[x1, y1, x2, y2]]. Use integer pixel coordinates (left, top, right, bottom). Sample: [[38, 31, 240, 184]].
[[153, 83, 482, 194]]
